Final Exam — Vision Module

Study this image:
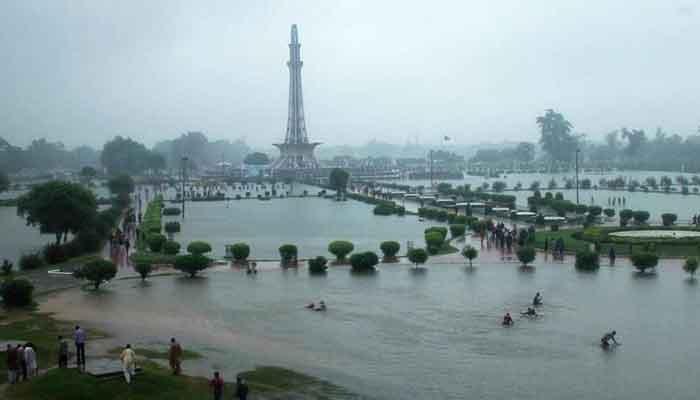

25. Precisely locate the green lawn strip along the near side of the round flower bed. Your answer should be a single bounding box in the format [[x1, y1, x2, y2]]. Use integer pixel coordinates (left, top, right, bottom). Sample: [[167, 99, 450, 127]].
[[535, 229, 700, 257]]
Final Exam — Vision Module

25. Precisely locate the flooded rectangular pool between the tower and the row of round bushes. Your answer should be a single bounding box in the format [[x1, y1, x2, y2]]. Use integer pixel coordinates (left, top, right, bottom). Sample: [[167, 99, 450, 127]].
[[164, 196, 435, 259]]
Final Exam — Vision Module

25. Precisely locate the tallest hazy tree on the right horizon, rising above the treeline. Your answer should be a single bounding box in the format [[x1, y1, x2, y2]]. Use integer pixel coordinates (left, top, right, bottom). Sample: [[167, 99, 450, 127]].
[[537, 109, 579, 162]]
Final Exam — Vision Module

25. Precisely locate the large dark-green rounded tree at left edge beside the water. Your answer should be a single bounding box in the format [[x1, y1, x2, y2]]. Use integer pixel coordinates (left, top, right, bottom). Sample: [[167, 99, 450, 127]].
[[17, 181, 97, 244]]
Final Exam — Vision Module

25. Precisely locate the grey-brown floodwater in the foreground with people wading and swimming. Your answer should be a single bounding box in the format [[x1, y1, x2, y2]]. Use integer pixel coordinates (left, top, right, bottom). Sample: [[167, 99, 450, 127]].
[[42, 244, 700, 400]]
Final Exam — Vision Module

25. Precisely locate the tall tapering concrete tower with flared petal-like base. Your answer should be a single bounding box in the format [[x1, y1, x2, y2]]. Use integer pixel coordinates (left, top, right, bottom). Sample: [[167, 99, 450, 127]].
[[272, 25, 320, 170]]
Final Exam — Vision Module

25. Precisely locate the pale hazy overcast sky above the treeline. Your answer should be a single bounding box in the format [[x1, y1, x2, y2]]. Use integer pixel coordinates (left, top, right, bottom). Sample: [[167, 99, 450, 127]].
[[0, 0, 700, 146]]
